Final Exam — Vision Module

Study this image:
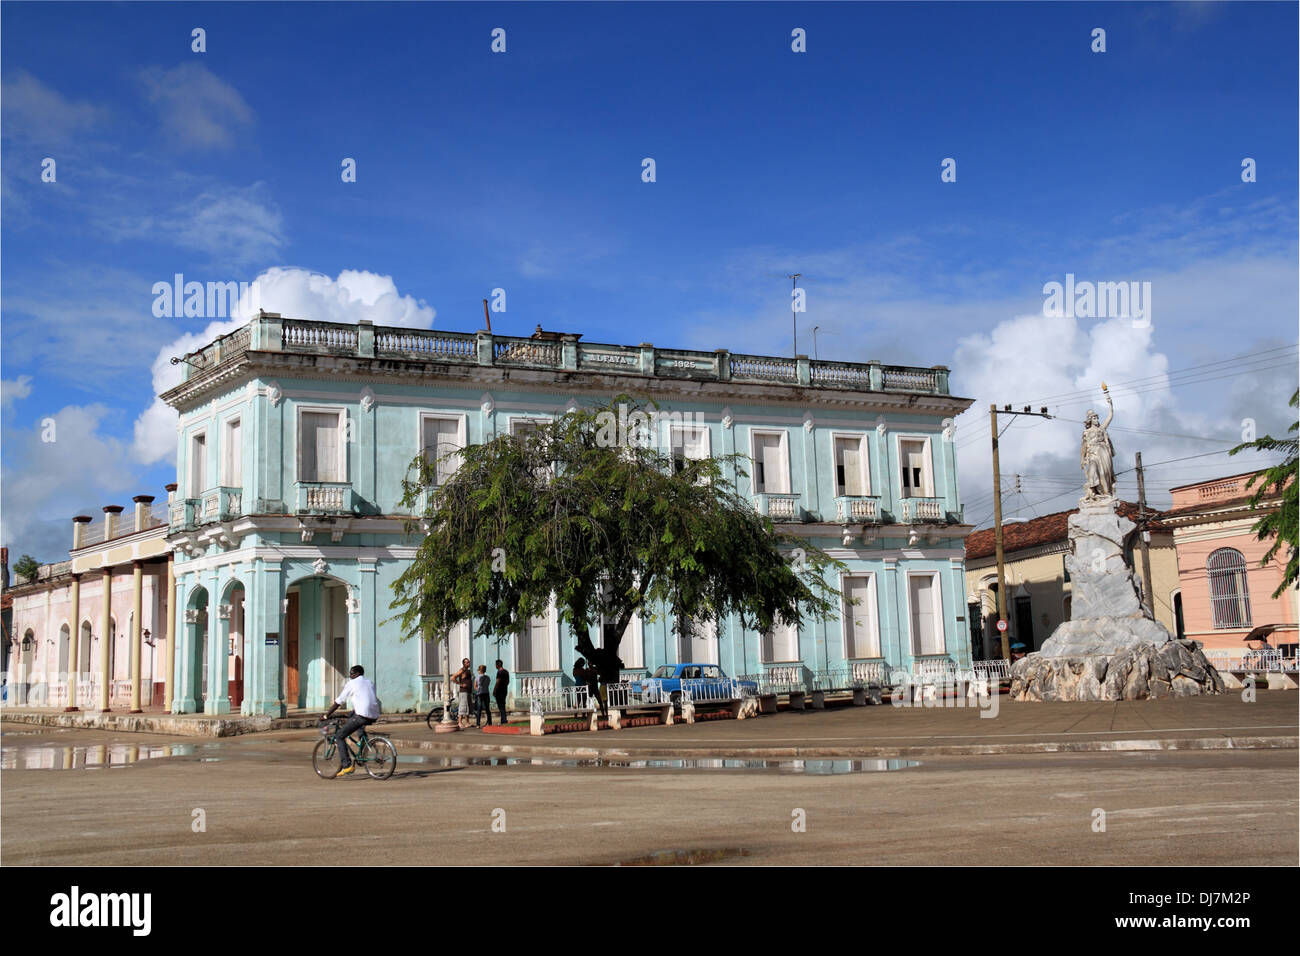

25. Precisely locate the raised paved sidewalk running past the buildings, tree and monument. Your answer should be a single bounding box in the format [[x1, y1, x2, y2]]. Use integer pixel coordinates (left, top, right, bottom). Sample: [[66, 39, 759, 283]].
[[0, 691, 1300, 757]]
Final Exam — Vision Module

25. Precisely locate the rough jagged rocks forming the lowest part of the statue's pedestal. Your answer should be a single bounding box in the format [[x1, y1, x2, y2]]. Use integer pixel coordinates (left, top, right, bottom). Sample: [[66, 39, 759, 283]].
[[1010, 642, 1223, 701]]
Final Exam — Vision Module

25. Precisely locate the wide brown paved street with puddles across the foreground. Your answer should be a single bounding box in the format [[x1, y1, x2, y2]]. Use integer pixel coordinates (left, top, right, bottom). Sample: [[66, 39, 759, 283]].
[[3, 696, 1297, 865]]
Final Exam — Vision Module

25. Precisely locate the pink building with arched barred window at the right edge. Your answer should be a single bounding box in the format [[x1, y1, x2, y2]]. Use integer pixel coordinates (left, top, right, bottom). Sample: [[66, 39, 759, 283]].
[[1161, 473, 1296, 654]]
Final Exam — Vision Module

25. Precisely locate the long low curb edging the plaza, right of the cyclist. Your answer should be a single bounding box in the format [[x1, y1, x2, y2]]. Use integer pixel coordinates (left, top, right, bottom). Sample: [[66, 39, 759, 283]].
[[394, 736, 1300, 760]]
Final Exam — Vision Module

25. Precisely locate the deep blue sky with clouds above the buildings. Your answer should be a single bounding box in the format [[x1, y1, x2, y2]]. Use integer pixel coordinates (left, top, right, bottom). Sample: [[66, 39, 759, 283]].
[[0, 3, 1297, 559]]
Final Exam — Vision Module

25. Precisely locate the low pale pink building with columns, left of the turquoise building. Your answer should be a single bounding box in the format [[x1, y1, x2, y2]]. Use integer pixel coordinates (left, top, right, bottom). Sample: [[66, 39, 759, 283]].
[[5, 496, 174, 713]]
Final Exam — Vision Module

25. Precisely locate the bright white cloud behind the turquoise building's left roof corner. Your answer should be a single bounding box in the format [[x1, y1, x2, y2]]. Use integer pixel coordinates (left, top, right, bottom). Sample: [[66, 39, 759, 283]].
[[131, 268, 437, 464]]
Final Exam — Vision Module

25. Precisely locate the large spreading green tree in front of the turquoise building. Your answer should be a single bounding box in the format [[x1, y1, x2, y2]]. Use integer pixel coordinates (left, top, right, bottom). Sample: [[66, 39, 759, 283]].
[[391, 397, 842, 682]]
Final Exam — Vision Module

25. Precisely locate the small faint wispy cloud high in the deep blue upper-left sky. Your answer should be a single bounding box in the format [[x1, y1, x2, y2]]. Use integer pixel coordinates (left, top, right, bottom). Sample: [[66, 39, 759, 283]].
[[139, 62, 254, 150]]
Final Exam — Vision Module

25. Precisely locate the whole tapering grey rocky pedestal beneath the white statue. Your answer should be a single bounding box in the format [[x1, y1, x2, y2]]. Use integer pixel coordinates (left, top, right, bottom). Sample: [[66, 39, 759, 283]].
[[1010, 497, 1223, 700]]
